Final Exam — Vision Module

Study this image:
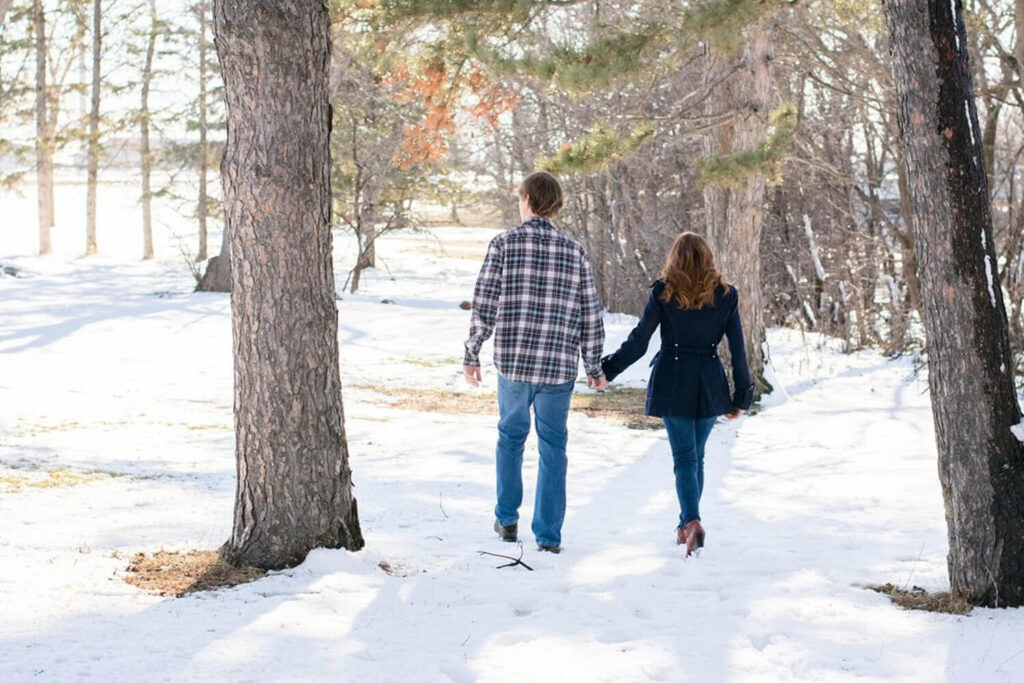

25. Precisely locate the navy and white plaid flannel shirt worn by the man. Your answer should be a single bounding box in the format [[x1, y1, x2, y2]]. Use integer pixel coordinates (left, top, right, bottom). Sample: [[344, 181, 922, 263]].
[[463, 216, 604, 384]]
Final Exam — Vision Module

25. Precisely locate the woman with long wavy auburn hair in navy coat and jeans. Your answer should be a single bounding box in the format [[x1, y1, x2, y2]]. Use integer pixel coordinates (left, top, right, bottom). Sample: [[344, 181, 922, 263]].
[[601, 232, 754, 557]]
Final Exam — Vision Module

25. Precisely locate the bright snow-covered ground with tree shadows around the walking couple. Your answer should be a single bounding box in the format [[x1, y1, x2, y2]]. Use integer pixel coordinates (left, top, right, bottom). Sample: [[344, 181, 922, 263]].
[[0, 187, 1024, 683]]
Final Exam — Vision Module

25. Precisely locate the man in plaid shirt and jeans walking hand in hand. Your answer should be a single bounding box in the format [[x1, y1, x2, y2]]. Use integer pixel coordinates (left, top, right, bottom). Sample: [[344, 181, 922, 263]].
[[463, 173, 608, 553]]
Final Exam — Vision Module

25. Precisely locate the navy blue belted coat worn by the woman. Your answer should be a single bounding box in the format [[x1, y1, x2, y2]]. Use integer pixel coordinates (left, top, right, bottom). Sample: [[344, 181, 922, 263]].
[[601, 281, 754, 418]]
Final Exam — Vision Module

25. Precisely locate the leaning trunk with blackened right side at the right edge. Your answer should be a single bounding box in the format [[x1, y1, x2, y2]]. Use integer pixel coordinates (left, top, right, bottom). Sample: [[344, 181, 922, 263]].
[[885, 0, 1024, 606]]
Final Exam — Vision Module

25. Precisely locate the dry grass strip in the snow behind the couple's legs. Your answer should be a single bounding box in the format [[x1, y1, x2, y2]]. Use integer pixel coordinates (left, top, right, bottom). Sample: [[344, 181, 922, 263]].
[[358, 386, 662, 429]]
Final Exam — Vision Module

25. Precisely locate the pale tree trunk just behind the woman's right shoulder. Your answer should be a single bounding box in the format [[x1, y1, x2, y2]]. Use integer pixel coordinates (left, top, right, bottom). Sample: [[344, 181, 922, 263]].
[[703, 28, 773, 397]]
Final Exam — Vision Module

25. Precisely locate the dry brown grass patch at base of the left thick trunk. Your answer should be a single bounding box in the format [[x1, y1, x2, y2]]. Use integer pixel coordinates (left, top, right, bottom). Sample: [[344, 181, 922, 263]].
[[125, 550, 266, 597]]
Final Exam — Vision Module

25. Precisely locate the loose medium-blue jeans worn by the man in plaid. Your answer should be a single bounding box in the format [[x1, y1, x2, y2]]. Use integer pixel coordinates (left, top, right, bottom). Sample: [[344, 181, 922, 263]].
[[495, 375, 572, 546]]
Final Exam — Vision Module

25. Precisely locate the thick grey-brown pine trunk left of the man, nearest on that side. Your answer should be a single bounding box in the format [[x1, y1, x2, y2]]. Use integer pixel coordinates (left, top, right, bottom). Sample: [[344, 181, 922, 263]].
[[214, 0, 362, 568]]
